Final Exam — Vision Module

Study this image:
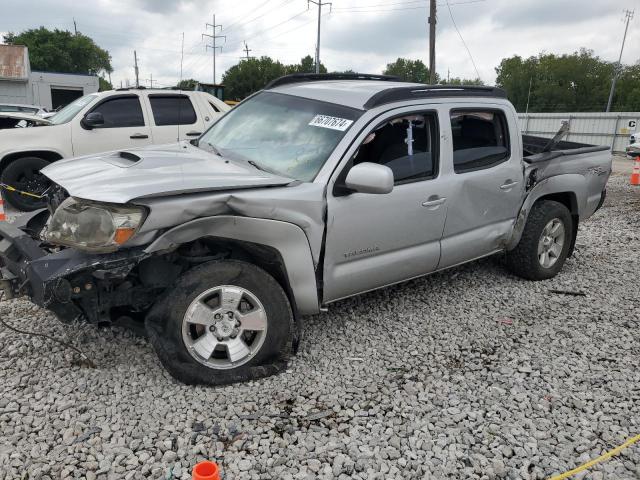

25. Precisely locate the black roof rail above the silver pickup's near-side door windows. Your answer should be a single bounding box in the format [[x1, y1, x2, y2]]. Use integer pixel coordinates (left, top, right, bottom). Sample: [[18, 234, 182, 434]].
[[363, 85, 507, 109]]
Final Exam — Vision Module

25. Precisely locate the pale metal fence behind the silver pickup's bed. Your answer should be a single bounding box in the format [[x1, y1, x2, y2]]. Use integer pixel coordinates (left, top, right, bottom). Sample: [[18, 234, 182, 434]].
[[518, 112, 640, 152]]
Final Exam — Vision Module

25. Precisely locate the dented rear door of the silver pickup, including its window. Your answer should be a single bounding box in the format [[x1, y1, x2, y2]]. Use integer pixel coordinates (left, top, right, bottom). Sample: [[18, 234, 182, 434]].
[[439, 104, 524, 268]]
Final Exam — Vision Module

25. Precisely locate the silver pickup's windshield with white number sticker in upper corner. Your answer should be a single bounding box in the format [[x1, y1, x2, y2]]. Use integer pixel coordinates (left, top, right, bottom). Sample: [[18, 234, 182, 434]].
[[200, 92, 362, 182]]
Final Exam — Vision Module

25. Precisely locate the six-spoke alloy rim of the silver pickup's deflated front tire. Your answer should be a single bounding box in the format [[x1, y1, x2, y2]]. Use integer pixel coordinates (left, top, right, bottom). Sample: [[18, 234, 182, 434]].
[[182, 285, 267, 370]]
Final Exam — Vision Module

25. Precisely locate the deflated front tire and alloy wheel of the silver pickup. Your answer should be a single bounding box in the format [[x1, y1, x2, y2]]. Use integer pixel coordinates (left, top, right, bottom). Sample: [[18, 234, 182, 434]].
[[145, 260, 295, 385]]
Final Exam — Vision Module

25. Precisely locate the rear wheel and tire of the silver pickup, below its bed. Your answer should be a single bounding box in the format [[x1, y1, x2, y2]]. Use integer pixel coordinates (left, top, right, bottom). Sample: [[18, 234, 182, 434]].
[[507, 200, 573, 280]]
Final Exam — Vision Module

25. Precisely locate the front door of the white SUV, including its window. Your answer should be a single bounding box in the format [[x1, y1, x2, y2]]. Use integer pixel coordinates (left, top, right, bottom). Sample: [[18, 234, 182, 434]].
[[72, 94, 151, 156]]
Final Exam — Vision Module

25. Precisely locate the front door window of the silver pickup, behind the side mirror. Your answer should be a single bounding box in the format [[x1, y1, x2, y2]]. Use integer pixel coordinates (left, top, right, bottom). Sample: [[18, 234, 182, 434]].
[[353, 113, 438, 185]]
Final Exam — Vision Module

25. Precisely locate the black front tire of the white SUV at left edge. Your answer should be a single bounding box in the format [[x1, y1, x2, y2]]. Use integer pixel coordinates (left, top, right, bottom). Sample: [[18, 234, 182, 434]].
[[1, 157, 51, 212]]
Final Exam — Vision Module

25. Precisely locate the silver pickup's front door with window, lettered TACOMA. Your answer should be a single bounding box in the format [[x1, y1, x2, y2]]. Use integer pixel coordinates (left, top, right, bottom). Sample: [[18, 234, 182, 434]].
[[323, 111, 447, 302]]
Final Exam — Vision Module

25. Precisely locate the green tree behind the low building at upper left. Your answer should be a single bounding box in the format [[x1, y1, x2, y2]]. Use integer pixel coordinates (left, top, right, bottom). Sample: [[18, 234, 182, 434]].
[[4, 27, 113, 74]]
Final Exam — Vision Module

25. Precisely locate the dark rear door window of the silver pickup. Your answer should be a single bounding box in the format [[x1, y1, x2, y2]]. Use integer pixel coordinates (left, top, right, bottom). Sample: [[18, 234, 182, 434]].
[[451, 109, 509, 173]]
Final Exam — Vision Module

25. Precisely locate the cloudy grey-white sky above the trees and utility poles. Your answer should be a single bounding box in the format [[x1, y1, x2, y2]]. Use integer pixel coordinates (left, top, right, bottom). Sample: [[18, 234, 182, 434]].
[[0, 0, 640, 87]]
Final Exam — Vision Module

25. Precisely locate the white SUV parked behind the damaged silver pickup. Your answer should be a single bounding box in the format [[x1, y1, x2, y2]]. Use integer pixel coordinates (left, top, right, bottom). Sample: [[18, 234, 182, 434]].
[[0, 89, 230, 210]]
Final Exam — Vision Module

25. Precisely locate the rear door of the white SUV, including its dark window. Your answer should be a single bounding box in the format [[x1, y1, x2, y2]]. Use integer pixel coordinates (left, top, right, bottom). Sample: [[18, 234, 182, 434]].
[[147, 93, 204, 144]]
